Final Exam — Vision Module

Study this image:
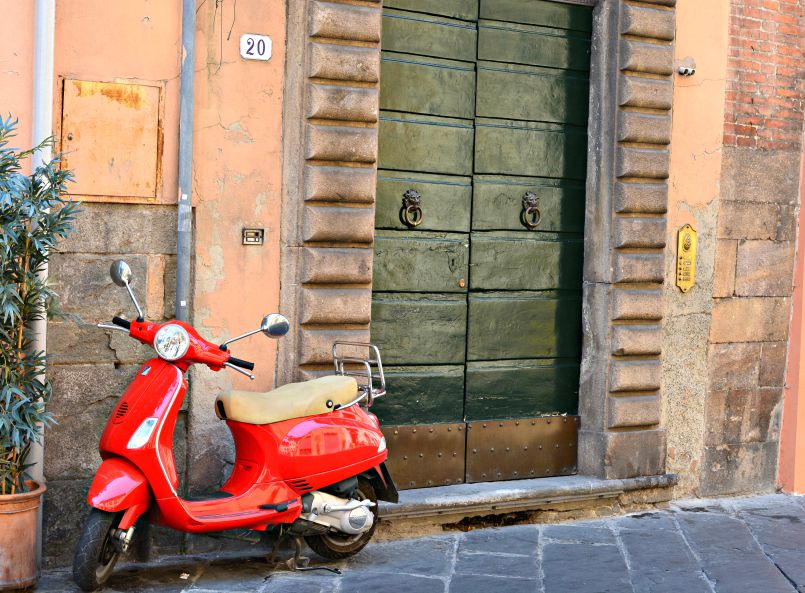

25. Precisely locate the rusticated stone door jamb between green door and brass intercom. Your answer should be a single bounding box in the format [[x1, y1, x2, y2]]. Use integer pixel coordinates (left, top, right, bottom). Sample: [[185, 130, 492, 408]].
[[579, 0, 676, 478]]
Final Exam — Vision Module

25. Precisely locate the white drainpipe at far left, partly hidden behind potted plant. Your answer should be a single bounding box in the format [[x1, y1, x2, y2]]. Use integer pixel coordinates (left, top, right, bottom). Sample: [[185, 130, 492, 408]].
[[30, 0, 56, 566]]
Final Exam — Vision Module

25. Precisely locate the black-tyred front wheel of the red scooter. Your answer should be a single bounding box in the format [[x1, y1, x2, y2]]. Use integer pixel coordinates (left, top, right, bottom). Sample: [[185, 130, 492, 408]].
[[73, 508, 120, 591]]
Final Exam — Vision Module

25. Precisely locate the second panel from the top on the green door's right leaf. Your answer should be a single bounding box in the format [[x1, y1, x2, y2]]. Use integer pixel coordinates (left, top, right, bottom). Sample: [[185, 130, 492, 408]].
[[478, 21, 590, 72]]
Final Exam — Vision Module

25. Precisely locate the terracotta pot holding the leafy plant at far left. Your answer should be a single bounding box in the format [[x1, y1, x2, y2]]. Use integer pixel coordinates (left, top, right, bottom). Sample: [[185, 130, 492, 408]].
[[0, 482, 45, 591]]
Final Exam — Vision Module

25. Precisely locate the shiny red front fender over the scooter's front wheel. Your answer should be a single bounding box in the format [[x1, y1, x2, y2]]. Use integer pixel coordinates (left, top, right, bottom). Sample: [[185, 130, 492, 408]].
[[87, 457, 153, 513]]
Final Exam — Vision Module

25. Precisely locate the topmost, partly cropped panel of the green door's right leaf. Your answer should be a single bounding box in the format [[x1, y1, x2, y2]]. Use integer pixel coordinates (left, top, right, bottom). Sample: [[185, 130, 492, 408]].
[[478, 0, 593, 33]]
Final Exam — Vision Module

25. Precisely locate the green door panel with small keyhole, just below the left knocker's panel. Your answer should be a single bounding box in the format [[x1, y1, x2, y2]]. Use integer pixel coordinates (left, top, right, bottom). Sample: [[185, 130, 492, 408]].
[[372, 231, 469, 293]]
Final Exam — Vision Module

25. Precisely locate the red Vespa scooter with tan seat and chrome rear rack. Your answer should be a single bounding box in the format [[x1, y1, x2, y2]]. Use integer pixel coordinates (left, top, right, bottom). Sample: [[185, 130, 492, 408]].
[[73, 260, 397, 591]]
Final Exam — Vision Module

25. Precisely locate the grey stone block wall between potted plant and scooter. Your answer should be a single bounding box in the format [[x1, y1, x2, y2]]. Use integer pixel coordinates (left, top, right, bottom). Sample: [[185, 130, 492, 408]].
[[43, 203, 178, 565]]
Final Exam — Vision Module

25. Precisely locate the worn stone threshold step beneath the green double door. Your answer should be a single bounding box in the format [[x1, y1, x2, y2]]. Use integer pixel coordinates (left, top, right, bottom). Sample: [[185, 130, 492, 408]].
[[379, 474, 678, 520]]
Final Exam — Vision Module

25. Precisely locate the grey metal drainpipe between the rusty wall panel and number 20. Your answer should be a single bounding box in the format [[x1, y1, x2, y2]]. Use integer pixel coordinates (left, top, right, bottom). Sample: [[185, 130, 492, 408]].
[[176, 0, 196, 321]]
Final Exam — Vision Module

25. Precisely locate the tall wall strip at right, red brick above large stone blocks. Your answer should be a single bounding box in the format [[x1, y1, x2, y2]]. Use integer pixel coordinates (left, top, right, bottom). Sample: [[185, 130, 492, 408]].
[[701, 0, 805, 495]]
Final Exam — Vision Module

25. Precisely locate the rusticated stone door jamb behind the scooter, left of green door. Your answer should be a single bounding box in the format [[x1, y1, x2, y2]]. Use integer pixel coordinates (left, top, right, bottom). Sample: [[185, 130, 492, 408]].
[[279, 0, 381, 383]]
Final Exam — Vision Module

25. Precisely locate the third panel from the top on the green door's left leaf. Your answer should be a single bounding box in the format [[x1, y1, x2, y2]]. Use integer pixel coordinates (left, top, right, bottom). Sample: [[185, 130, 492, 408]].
[[380, 52, 475, 119]]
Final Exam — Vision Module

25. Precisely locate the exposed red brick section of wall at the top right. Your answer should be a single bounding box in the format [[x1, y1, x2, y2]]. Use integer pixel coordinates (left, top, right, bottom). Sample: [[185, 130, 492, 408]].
[[724, 0, 805, 150]]
